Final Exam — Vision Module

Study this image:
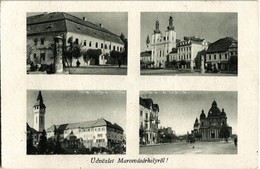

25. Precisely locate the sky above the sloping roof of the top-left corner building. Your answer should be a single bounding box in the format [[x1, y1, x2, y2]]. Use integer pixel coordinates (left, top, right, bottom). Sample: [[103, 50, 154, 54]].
[[27, 12, 128, 37]]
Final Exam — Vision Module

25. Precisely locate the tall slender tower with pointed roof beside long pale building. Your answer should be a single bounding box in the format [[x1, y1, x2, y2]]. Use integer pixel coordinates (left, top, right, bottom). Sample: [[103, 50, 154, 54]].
[[33, 91, 46, 132]]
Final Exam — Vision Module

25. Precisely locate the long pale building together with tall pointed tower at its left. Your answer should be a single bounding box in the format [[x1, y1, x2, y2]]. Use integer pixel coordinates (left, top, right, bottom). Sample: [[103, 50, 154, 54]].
[[27, 91, 124, 151]]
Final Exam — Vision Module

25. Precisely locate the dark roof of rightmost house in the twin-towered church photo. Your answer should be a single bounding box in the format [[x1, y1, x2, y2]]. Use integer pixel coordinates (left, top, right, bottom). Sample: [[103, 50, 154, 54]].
[[207, 37, 237, 53]]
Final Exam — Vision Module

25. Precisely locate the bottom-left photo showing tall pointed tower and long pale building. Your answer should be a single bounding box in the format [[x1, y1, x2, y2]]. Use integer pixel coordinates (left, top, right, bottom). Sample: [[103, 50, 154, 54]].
[[26, 90, 126, 155]]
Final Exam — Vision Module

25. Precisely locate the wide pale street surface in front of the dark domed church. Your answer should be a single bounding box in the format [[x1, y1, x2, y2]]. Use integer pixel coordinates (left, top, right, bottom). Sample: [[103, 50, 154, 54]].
[[140, 141, 237, 154]]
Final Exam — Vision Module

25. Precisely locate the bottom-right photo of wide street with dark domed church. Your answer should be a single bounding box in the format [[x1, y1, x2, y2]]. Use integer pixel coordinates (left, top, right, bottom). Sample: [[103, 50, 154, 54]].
[[139, 91, 239, 154]]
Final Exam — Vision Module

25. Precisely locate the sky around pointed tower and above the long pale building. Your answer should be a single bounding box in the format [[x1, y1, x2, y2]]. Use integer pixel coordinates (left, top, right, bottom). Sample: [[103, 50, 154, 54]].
[[27, 90, 126, 130]]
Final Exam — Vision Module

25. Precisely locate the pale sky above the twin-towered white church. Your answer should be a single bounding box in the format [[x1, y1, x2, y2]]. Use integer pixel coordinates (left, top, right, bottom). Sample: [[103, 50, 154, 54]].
[[141, 12, 237, 51]]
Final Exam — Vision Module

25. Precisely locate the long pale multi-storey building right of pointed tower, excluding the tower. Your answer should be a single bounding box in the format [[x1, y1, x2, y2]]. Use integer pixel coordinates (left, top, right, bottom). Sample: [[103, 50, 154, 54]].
[[46, 118, 124, 149]]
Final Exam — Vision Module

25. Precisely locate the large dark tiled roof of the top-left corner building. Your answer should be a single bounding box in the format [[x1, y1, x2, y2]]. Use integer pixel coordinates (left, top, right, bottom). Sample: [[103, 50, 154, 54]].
[[27, 12, 124, 44]]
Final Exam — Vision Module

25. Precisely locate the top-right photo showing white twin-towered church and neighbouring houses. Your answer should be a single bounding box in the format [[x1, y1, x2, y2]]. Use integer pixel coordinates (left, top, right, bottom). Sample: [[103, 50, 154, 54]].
[[140, 12, 238, 76]]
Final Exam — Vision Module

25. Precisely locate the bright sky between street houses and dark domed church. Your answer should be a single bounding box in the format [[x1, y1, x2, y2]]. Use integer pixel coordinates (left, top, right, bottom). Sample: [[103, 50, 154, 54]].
[[140, 91, 237, 135]]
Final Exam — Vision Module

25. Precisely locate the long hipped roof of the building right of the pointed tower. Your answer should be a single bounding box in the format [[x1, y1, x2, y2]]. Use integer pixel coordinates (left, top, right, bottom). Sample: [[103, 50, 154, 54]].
[[46, 118, 123, 133]]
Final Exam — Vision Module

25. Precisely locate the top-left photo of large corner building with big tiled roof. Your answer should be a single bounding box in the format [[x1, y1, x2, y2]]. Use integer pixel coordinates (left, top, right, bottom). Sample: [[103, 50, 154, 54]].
[[26, 12, 128, 75]]
